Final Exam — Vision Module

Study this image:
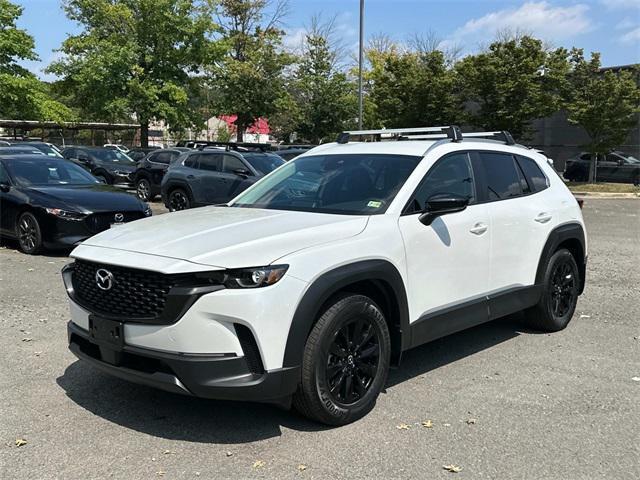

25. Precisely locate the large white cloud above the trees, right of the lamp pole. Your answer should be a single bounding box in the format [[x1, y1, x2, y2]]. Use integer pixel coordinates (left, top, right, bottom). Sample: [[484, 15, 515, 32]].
[[447, 1, 593, 46]]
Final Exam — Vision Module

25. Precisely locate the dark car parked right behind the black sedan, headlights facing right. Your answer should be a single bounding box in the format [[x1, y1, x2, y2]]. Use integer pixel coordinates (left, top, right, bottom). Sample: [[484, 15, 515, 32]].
[[62, 147, 136, 186]]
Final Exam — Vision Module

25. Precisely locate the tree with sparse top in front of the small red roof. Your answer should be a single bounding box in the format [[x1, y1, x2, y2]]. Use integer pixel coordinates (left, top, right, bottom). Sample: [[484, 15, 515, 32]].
[[210, 0, 292, 142]]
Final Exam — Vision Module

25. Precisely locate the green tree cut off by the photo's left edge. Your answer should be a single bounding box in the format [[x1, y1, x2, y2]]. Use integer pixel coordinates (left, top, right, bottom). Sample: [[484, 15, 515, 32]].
[[0, 0, 73, 122]]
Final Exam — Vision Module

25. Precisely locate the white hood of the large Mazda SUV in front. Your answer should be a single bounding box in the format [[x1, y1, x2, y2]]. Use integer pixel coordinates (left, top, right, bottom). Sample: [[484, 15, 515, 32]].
[[83, 207, 368, 268]]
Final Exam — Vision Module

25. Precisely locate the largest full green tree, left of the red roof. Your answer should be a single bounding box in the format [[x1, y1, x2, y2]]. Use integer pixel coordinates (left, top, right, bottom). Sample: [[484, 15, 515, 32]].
[[48, 0, 221, 147]]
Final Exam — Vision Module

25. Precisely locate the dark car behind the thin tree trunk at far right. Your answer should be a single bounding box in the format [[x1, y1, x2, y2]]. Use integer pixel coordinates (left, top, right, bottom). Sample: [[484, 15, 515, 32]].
[[564, 152, 640, 185]]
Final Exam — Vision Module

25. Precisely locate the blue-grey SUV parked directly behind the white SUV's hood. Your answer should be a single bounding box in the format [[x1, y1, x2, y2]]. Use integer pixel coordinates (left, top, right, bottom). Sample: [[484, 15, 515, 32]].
[[161, 147, 285, 211]]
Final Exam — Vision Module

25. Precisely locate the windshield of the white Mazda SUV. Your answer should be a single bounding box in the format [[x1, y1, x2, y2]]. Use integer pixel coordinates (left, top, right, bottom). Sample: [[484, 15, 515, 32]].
[[231, 154, 422, 215]]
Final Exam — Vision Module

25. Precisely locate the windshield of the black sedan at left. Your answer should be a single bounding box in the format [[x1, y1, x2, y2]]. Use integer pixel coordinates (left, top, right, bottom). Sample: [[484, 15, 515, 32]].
[[5, 157, 100, 187]]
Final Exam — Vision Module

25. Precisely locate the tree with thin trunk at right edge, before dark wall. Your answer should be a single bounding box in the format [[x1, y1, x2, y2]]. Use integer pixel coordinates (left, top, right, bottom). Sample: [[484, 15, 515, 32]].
[[566, 49, 640, 183]]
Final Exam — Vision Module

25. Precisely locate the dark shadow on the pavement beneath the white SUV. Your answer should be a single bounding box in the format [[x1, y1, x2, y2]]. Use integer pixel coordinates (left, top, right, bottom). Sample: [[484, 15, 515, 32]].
[[57, 316, 536, 444]]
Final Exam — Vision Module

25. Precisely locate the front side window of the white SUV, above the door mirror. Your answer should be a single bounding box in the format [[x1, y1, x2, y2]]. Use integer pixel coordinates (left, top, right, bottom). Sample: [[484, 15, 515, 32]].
[[410, 153, 476, 212]]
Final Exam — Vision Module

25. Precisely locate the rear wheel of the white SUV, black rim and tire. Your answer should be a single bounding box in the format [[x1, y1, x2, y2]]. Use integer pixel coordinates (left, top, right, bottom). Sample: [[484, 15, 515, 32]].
[[525, 248, 580, 332]]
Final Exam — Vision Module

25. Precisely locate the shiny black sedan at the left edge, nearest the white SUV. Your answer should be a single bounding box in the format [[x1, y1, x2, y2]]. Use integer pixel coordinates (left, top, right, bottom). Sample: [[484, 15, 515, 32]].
[[0, 155, 151, 254]]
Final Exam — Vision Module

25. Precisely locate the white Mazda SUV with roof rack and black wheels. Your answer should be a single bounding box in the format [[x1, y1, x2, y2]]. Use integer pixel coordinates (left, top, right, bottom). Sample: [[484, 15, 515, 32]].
[[63, 127, 587, 425]]
